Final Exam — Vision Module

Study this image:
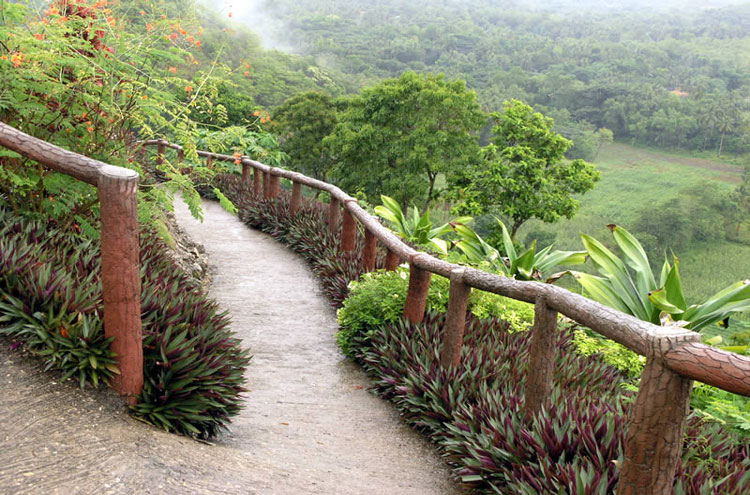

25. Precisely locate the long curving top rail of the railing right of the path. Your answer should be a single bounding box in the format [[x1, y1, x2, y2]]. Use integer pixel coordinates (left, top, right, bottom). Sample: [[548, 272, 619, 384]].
[[142, 140, 750, 396]]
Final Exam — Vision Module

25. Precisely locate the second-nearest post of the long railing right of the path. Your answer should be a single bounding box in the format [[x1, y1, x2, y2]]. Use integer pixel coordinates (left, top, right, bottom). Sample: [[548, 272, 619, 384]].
[[523, 297, 557, 421]]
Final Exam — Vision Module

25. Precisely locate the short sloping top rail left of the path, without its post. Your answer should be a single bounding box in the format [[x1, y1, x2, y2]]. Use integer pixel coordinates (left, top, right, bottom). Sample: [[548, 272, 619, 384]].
[[0, 122, 138, 186]]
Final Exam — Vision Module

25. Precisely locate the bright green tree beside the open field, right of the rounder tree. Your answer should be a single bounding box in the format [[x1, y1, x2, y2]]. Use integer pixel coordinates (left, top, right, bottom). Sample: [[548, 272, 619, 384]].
[[450, 100, 599, 237]]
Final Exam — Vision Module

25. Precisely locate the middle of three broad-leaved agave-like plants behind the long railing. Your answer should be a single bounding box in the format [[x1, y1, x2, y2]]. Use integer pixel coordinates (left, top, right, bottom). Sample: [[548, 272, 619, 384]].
[[454, 219, 586, 281]]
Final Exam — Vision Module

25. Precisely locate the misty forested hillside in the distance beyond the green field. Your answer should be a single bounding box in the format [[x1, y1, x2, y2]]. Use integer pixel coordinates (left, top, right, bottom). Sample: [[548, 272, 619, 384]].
[[244, 0, 750, 157]]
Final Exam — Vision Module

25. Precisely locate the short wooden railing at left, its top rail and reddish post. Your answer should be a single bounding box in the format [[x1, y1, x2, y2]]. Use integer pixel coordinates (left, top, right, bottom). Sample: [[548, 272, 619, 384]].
[[0, 122, 143, 404]]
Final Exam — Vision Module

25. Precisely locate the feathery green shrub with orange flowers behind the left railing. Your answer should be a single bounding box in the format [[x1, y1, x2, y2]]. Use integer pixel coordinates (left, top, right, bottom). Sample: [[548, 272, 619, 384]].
[[0, 1, 223, 231]]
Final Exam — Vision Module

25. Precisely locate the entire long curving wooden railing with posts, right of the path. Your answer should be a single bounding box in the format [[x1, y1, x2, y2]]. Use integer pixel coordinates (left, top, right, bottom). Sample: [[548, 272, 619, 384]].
[[143, 140, 750, 495]]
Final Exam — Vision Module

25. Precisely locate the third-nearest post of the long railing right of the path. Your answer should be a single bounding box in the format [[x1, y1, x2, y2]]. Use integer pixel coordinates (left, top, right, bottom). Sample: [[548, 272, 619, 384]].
[[440, 268, 471, 368]]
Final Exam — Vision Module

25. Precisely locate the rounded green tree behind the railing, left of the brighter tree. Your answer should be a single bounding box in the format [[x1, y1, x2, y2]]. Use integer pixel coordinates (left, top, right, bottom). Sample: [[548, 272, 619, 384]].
[[324, 72, 485, 207]]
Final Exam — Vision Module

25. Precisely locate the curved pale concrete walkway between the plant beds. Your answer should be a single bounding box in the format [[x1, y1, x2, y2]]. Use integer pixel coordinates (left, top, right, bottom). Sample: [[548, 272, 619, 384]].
[[0, 203, 463, 495]]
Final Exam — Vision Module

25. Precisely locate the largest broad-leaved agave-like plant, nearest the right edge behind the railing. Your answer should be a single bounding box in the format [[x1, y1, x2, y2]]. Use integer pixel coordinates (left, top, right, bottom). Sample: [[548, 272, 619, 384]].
[[571, 225, 750, 331]]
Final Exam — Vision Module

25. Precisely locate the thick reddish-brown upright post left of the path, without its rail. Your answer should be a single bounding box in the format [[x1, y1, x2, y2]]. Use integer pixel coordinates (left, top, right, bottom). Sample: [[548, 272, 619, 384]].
[[98, 166, 143, 405]]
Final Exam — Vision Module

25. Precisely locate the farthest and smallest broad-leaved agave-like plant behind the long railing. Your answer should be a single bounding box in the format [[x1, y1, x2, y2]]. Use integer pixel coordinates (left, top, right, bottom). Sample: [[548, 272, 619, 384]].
[[375, 195, 472, 254]]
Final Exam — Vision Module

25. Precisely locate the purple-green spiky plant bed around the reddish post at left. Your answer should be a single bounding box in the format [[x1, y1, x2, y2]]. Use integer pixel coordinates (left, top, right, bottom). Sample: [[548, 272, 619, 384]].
[[0, 209, 249, 438]]
